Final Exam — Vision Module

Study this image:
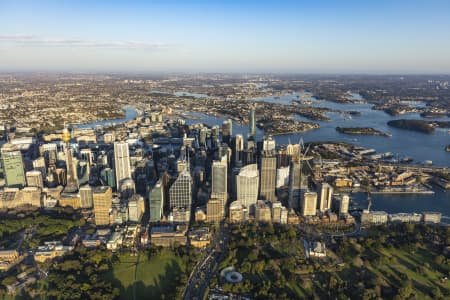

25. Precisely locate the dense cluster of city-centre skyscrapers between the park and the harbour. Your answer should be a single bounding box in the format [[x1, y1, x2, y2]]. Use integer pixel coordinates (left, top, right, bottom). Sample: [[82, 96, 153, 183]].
[[0, 106, 348, 225]]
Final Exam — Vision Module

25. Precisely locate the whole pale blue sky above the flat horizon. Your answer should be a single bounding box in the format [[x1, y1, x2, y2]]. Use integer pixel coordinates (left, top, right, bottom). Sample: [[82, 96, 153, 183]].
[[0, 0, 450, 74]]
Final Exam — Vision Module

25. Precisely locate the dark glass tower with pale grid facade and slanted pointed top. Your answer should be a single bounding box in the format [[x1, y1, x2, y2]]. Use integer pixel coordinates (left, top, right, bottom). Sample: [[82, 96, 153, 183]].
[[169, 170, 192, 211]]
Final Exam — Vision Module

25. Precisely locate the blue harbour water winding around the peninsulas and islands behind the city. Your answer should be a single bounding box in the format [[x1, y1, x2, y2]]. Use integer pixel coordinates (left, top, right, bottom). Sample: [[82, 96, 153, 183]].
[[79, 94, 450, 216]]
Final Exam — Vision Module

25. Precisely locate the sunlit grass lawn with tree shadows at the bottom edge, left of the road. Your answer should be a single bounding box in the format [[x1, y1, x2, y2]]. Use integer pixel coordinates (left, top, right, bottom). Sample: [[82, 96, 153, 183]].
[[105, 250, 185, 299]]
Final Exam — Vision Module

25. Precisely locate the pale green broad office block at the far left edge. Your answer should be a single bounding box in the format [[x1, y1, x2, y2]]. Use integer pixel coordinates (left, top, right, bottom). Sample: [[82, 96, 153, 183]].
[[1, 144, 26, 188]]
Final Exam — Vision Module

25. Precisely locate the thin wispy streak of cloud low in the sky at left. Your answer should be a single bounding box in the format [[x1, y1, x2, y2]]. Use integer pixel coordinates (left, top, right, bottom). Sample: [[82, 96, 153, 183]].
[[0, 35, 176, 50]]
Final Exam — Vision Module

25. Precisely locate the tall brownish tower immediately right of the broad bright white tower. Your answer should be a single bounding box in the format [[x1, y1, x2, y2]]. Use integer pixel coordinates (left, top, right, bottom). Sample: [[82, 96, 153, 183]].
[[259, 150, 277, 202]]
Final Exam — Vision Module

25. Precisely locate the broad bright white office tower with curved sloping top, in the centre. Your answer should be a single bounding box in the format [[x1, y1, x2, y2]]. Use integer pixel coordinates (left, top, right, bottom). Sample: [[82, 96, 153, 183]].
[[236, 164, 259, 208]]
